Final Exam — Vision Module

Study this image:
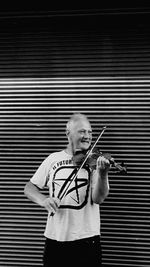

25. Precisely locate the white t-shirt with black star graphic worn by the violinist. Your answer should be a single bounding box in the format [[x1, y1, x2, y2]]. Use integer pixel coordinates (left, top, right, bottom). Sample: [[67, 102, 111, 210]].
[[31, 150, 100, 241]]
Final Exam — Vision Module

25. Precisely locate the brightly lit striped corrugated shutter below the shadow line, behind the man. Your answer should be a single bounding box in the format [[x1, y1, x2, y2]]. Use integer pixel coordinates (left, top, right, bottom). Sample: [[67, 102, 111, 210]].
[[0, 78, 150, 266]]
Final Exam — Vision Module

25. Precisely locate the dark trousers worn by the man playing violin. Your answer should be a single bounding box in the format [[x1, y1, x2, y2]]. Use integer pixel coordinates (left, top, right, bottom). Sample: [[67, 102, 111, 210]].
[[43, 236, 101, 267]]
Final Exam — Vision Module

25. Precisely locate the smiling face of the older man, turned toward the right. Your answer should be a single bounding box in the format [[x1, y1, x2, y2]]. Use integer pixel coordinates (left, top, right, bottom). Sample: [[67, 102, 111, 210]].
[[69, 119, 92, 151]]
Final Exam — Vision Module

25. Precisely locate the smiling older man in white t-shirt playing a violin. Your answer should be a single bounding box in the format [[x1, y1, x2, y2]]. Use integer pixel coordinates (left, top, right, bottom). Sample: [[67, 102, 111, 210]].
[[24, 113, 110, 267]]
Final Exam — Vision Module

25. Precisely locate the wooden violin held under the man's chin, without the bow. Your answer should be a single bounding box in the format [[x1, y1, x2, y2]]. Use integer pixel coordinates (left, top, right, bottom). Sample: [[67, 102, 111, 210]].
[[73, 149, 127, 174]]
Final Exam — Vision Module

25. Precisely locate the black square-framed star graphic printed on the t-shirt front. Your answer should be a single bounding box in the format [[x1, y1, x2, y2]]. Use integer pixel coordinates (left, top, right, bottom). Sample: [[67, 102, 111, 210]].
[[53, 166, 90, 209]]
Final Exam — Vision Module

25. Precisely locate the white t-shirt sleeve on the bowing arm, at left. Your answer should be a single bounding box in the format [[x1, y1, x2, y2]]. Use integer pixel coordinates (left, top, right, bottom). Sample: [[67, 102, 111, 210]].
[[30, 157, 50, 189]]
